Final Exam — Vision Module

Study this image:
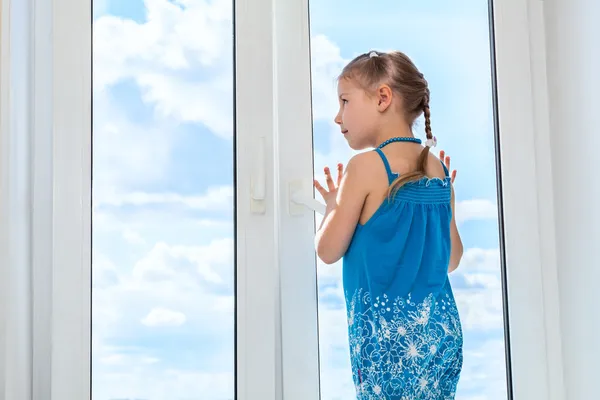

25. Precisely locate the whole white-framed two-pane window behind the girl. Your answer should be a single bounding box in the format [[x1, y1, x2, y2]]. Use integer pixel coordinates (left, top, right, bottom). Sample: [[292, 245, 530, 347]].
[[0, 0, 562, 400]]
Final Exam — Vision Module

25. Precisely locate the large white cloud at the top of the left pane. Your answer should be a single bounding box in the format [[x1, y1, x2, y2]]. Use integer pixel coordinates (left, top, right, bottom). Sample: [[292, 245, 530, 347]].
[[94, 0, 233, 138]]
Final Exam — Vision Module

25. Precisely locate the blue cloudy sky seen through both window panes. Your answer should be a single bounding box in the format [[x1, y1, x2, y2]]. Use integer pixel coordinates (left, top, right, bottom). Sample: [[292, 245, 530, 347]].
[[92, 0, 506, 400]]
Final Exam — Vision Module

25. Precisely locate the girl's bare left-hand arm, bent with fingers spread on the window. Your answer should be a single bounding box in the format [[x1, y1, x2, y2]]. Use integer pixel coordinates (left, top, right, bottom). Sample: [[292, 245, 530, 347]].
[[315, 153, 369, 264]]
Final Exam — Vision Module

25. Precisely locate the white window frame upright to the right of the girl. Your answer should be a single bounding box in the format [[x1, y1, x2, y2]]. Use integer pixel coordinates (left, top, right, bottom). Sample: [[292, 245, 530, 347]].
[[493, 0, 564, 399]]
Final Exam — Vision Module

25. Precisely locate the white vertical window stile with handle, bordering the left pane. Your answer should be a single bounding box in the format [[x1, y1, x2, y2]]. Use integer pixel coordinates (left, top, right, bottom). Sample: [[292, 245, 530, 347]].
[[234, 0, 282, 400]]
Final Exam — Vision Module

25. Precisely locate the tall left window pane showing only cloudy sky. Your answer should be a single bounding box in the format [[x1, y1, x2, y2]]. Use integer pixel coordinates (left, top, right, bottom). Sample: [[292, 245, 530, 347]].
[[92, 0, 235, 400]]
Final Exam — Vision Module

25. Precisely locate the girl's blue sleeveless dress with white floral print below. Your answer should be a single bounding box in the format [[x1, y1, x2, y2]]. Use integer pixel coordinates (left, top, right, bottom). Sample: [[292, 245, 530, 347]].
[[343, 148, 463, 400]]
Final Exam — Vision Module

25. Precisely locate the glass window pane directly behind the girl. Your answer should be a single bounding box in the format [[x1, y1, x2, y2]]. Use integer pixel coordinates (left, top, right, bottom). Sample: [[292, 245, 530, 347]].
[[310, 0, 507, 400]]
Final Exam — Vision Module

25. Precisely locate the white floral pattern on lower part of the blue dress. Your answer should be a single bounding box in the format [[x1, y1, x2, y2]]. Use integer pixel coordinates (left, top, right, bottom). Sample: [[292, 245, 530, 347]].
[[347, 289, 463, 400]]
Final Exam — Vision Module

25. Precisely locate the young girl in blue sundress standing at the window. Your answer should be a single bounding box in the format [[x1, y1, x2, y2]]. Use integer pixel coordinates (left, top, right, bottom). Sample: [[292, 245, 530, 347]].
[[315, 51, 463, 400]]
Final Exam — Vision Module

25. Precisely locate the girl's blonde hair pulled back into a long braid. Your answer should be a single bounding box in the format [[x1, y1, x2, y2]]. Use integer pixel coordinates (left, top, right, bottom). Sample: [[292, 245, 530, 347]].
[[338, 51, 433, 195]]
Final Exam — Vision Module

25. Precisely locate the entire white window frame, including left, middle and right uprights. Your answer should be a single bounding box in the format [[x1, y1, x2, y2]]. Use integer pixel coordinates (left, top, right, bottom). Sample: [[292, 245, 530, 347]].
[[0, 0, 564, 400]]
